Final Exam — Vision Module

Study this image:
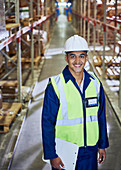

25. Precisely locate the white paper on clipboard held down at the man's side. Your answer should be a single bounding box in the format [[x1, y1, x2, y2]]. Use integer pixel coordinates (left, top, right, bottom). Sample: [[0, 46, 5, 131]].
[[43, 138, 79, 170]]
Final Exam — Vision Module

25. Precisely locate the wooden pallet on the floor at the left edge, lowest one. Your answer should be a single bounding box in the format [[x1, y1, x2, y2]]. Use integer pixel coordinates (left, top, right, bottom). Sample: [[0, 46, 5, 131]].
[[0, 103, 22, 133]]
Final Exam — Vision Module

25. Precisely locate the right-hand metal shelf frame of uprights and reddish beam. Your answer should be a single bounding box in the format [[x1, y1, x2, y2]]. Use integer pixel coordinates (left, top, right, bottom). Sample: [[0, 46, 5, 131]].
[[72, 0, 121, 108]]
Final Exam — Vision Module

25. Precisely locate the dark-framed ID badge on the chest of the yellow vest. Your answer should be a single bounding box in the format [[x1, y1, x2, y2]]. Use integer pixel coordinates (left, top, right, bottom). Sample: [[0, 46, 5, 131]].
[[86, 97, 98, 107]]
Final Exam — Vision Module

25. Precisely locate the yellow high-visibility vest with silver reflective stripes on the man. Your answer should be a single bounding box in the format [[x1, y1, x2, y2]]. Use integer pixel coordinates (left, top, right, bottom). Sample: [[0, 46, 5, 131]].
[[51, 73, 100, 147]]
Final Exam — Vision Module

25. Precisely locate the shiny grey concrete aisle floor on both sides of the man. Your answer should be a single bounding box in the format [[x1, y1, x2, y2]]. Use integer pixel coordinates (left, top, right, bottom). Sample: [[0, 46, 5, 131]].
[[7, 15, 121, 170]]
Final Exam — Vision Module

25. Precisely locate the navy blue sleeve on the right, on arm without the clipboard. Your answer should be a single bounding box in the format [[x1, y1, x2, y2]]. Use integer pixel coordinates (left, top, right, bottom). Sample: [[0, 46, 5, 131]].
[[98, 84, 109, 149]]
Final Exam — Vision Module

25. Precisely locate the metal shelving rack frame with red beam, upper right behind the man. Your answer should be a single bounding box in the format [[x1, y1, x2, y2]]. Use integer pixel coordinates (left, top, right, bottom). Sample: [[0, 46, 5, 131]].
[[72, 0, 121, 108]]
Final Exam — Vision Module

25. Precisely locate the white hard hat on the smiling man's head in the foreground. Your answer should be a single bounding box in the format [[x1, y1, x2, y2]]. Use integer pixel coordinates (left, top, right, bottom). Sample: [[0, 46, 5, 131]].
[[64, 35, 89, 52]]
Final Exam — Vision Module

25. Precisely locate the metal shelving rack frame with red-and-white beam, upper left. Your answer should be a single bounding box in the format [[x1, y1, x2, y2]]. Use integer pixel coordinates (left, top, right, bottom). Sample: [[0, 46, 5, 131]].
[[0, 0, 55, 102]]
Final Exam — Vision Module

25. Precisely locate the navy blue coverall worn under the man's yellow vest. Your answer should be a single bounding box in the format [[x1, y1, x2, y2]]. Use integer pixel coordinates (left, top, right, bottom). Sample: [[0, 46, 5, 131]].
[[42, 66, 109, 170]]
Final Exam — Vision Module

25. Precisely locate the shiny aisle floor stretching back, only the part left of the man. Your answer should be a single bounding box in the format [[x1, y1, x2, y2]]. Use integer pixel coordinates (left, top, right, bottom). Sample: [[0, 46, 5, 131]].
[[10, 15, 74, 170]]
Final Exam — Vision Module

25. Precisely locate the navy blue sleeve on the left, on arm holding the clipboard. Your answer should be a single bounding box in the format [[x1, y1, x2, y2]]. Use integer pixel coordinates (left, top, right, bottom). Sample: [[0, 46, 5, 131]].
[[42, 81, 59, 159]]
